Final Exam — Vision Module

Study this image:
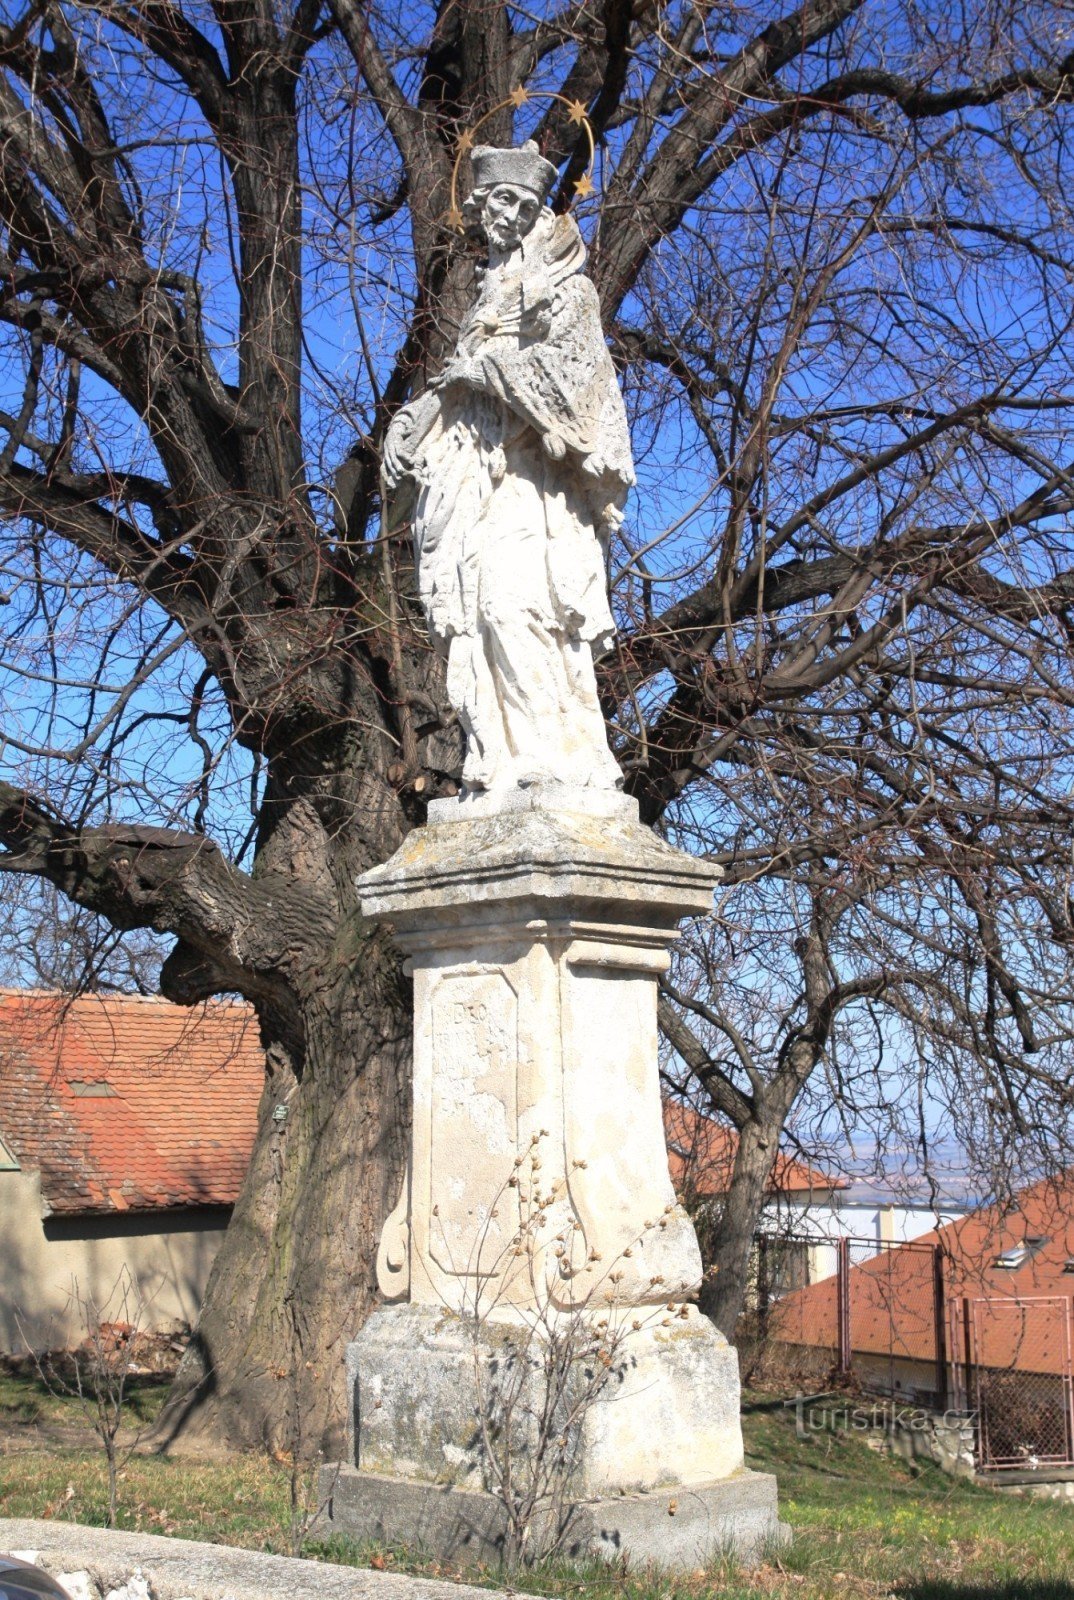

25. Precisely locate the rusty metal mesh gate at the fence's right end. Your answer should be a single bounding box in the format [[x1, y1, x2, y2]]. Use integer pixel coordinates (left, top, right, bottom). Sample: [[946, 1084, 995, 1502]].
[[952, 1294, 1074, 1472]]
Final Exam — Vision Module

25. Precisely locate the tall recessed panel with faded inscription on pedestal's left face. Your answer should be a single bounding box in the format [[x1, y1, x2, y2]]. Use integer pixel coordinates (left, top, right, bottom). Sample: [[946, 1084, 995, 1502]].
[[429, 973, 519, 1277]]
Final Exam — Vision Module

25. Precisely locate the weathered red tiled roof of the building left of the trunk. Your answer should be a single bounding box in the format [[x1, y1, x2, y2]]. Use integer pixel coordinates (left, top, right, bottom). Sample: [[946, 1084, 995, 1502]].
[[0, 990, 264, 1214]]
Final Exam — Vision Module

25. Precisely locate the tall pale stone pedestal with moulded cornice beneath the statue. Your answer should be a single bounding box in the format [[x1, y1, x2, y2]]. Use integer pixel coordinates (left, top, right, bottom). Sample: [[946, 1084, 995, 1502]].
[[328, 789, 781, 1566]]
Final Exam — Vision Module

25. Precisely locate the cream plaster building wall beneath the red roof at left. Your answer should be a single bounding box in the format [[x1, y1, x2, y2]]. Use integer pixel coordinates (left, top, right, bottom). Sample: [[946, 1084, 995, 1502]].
[[0, 1171, 230, 1354]]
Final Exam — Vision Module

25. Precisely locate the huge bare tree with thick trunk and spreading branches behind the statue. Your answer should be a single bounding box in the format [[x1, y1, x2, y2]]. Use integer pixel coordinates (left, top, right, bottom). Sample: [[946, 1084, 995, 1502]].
[[0, 0, 1074, 1443]]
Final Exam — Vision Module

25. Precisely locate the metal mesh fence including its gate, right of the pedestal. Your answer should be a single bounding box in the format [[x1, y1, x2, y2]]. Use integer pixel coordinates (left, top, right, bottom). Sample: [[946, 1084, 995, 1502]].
[[736, 1235, 1074, 1472]]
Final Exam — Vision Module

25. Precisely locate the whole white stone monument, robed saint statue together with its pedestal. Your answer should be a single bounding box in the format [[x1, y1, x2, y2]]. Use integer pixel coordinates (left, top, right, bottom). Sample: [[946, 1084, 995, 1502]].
[[322, 144, 786, 1571]]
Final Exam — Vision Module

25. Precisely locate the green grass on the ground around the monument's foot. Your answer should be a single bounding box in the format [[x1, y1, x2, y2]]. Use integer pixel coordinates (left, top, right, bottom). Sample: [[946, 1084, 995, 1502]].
[[0, 1378, 1074, 1600]]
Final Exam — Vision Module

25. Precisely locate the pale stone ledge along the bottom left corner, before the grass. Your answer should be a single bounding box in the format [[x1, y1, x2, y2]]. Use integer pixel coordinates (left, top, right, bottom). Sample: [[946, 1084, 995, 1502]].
[[0, 1523, 505, 1600]]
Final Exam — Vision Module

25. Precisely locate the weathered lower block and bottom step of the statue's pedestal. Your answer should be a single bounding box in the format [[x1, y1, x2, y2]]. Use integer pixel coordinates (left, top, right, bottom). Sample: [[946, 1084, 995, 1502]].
[[322, 1306, 787, 1571]]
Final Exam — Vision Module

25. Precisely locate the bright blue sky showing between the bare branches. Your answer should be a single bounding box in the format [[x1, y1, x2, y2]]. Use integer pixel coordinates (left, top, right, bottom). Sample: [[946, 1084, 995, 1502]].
[[0, 0, 1074, 1196]]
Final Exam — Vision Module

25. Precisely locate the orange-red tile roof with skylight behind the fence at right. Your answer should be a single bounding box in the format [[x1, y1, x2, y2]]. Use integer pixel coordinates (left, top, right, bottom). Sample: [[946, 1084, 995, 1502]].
[[770, 1168, 1074, 1373]]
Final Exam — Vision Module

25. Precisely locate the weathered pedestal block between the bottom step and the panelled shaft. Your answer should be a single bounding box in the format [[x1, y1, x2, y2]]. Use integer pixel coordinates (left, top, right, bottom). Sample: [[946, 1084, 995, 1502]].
[[347, 1306, 743, 1499]]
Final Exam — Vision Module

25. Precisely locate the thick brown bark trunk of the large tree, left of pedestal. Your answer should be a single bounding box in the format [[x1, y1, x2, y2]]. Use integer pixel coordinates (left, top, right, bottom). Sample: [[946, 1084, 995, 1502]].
[[157, 870, 411, 1461]]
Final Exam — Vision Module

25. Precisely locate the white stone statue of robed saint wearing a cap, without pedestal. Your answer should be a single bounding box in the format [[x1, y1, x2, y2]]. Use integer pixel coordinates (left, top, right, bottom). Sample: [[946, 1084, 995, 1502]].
[[384, 142, 634, 795]]
